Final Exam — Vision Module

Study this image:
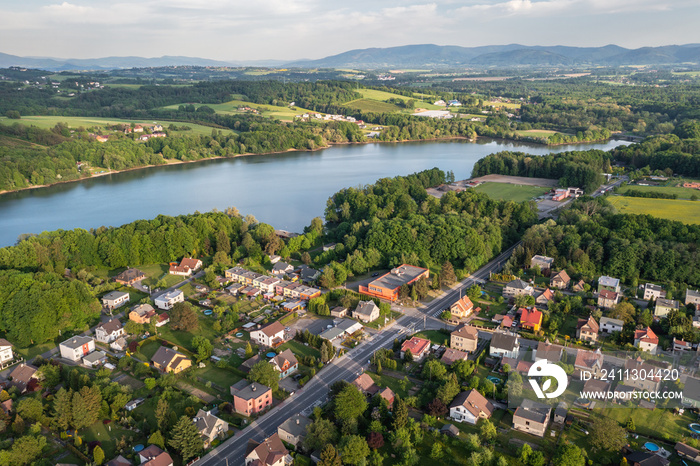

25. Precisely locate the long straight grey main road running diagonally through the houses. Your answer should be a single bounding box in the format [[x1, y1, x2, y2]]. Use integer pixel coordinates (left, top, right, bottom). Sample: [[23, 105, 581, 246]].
[[196, 243, 520, 466]]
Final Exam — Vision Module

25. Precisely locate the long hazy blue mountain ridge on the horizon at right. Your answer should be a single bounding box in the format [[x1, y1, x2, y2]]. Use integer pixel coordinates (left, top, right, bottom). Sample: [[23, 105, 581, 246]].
[[286, 44, 700, 69]]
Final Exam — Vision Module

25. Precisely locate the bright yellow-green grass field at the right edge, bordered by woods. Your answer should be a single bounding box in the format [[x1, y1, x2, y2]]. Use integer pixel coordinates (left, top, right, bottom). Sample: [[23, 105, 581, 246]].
[[608, 196, 700, 224]]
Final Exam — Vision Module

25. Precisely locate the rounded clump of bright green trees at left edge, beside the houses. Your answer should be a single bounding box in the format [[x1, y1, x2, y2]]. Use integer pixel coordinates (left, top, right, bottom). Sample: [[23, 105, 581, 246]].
[[0, 270, 101, 347]]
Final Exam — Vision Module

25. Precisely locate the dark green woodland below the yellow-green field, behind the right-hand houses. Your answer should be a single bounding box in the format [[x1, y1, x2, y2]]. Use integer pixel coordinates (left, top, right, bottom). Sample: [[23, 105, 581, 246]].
[[507, 199, 700, 290]]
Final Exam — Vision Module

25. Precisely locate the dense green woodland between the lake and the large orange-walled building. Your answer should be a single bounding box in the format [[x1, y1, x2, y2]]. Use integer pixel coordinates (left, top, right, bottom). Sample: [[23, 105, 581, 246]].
[[325, 168, 537, 271]]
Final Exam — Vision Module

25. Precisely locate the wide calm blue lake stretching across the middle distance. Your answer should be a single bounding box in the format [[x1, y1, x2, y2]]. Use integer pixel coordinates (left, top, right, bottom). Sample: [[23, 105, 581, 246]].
[[0, 139, 630, 246]]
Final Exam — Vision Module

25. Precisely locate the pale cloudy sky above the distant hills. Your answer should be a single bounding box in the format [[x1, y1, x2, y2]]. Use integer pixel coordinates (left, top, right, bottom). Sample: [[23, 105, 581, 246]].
[[0, 0, 700, 61]]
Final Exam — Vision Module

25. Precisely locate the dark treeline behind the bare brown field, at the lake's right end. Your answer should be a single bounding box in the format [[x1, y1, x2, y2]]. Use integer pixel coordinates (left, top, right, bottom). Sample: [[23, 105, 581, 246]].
[[472, 149, 612, 192]]
